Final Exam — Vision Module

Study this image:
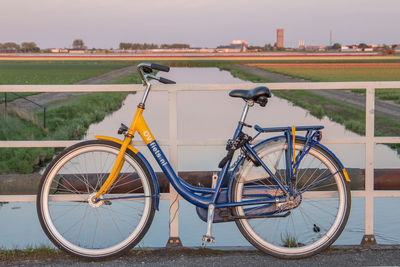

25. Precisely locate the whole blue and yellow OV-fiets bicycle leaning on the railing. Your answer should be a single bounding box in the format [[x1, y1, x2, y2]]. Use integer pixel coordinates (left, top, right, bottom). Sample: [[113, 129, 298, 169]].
[[37, 63, 351, 260]]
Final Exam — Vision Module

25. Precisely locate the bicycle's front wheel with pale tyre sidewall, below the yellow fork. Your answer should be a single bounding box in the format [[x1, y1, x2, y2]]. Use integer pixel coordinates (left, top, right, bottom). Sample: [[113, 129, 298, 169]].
[[37, 140, 155, 260]]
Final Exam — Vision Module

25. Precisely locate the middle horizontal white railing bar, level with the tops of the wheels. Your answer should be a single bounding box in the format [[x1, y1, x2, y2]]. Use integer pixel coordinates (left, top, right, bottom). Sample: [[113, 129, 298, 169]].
[[0, 137, 400, 148]]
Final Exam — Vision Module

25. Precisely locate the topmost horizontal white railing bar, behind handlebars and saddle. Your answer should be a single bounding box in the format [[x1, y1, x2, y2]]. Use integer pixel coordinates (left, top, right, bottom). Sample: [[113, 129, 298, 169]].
[[0, 81, 400, 92]]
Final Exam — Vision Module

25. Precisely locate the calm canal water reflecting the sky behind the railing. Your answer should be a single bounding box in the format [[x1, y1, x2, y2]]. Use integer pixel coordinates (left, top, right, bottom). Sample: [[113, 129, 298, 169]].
[[0, 68, 400, 249]]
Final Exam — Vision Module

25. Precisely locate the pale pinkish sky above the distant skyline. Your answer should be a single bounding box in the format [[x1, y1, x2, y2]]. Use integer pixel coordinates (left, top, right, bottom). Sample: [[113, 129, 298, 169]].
[[0, 0, 400, 48]]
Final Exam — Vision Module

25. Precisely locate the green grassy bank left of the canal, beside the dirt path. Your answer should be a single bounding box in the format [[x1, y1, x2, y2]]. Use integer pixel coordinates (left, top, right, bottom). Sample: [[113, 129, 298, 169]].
[[0, 65, 140, 174]]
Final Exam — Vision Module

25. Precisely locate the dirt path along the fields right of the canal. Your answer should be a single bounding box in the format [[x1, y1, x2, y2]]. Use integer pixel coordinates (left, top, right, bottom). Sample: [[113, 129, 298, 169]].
[[234, 64, 400, 120]]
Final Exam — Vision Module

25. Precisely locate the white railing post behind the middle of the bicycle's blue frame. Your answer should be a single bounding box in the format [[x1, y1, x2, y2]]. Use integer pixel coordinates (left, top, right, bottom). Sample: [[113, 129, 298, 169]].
[[167, 90, 182, 247]]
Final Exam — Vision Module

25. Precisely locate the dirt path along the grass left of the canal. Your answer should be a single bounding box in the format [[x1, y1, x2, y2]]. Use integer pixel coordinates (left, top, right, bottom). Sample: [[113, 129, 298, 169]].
[[3, 66, 136, 113]]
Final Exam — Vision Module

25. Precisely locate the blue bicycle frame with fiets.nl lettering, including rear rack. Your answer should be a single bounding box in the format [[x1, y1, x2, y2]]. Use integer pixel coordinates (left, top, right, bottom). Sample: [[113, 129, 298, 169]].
[[147, 123, 333, 211]]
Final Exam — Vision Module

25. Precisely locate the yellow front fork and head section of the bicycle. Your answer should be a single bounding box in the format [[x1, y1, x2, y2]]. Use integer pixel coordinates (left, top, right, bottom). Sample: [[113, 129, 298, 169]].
[[93, 107, 154, 202]]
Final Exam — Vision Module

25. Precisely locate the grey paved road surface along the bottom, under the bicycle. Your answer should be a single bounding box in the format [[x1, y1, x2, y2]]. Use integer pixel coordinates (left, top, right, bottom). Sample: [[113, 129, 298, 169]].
[[5, 247, 400, 267]]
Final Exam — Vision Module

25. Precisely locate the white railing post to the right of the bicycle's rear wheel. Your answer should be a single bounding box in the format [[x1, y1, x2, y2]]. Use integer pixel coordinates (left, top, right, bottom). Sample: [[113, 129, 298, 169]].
[[361, 88, 376, 246]]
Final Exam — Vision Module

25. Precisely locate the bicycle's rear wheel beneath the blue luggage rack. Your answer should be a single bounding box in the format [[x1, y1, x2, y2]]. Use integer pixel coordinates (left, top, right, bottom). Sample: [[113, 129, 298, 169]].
[[231, 138, 351, 258]]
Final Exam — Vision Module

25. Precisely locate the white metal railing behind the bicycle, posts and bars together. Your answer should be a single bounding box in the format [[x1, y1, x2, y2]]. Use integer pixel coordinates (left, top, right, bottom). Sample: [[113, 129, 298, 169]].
[[0, 82, 400, 247]]
